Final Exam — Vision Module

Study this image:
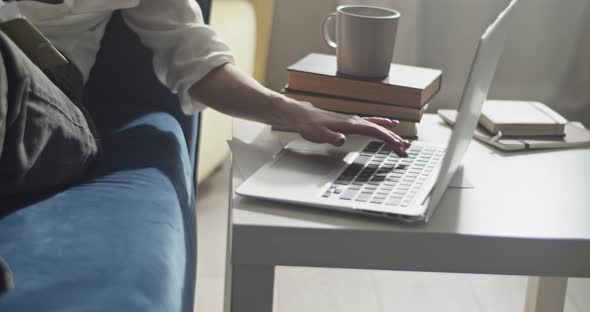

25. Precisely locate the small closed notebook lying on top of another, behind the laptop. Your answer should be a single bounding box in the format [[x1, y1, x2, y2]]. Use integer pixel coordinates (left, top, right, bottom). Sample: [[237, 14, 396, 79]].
[[479, 100, 567, 136]]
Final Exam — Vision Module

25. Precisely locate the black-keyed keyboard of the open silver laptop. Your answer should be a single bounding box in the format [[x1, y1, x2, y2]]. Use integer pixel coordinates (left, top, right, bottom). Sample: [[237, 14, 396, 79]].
[[322, 141, 445, 207]]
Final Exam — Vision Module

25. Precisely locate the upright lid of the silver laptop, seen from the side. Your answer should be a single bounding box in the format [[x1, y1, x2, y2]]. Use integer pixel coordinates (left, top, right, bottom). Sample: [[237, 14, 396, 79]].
[[426, 0, 518, 221]]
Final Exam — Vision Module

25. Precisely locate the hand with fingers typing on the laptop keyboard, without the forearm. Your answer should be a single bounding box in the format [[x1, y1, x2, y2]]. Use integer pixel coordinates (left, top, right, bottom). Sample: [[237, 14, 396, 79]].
[[276, 96, 410, 157]]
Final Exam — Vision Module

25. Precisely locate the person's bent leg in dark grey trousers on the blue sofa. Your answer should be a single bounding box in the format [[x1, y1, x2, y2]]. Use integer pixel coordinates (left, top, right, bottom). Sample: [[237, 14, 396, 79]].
[[0, 31, 98, 293]]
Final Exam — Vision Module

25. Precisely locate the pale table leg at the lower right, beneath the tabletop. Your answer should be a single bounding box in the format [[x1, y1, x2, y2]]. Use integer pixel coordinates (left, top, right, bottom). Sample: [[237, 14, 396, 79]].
[[524, 276, 567, 312]]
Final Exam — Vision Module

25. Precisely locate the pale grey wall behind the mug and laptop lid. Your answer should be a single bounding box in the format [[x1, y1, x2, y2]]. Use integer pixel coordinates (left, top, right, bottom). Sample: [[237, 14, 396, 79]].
[[267, 0, 590, 125]]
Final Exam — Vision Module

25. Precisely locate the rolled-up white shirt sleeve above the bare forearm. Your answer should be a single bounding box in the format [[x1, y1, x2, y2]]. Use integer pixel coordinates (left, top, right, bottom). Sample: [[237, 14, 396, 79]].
[[123, 0, 234, 113]]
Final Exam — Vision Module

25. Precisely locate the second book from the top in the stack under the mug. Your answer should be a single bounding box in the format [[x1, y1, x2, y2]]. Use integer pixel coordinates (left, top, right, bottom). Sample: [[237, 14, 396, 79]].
[[283, 88, 427, 121]]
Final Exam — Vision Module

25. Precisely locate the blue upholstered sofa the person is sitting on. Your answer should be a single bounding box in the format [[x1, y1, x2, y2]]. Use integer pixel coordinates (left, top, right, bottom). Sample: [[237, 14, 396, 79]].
[[0, 1, 209, 312]]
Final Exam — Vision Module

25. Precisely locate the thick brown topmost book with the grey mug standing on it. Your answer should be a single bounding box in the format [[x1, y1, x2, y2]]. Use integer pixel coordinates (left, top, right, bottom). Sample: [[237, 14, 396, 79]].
[[287, 53, 442, 108]]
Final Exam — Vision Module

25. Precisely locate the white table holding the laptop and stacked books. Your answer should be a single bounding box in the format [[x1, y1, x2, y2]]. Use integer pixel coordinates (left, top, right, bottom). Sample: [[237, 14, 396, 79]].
[[226, 115, 590, 312]]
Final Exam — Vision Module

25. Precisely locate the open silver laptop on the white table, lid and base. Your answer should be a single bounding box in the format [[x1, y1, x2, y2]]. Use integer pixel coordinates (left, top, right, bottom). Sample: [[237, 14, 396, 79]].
[[236, 0, 518, 222]]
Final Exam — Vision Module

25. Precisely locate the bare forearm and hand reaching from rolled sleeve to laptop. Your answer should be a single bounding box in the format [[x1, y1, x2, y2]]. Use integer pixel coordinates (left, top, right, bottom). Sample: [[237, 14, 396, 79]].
[[189, 63, 409, 156]]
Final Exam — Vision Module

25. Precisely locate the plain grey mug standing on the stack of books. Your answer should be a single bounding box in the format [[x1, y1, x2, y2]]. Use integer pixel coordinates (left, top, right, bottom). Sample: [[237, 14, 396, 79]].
[[322, 5, 401, 78]]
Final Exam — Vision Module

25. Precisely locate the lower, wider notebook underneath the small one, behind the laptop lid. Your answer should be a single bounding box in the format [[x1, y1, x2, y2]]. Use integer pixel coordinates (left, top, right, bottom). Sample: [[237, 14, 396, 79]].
[[438, 109, 590, 151]]
